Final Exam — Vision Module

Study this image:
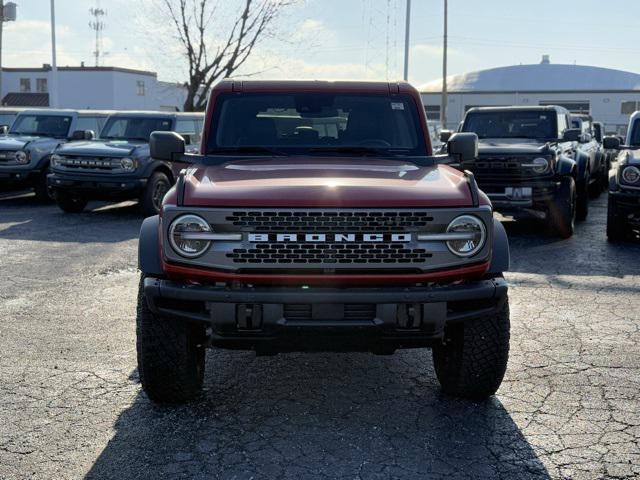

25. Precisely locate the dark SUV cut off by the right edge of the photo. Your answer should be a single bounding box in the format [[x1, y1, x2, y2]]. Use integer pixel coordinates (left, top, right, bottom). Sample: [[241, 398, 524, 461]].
[[604, 112, 640, 241]]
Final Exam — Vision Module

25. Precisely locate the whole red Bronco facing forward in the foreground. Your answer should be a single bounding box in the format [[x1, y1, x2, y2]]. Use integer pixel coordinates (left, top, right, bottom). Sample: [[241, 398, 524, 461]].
[[137, 81, 509, 402]]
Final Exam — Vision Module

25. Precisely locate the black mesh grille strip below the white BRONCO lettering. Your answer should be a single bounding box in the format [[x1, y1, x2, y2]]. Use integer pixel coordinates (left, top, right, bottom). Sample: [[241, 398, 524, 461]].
[[227, 243, 432, 264]]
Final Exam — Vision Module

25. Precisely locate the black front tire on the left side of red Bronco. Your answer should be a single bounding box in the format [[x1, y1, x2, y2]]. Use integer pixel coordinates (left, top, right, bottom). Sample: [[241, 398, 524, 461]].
[[136, 275, 206, 403]]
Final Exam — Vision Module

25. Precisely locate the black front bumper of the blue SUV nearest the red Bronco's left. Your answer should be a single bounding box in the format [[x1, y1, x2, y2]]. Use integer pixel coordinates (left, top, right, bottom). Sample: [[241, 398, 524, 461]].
[[47, 172, 147, 200]]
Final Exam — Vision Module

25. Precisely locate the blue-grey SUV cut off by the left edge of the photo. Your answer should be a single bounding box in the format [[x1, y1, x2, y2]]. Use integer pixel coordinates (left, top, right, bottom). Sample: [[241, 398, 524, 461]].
[[0, 109, 109, 201]]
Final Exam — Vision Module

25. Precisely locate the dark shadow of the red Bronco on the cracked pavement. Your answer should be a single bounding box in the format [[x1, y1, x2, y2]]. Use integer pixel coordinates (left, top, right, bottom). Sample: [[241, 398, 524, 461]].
[[86, 351, 549, 479]]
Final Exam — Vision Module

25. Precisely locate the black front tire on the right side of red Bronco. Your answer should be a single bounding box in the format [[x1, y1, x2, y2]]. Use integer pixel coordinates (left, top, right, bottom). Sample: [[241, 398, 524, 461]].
[[433, 298, 510, 400]]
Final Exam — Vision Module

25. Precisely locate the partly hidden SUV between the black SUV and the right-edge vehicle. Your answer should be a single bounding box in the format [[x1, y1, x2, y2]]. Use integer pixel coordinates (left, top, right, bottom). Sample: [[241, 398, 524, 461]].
[[571, 114, 609, 197]]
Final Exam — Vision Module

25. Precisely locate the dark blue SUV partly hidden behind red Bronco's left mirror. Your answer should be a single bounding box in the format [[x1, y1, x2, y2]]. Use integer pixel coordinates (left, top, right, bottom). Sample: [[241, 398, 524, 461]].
[[49, 112, 204, 216]]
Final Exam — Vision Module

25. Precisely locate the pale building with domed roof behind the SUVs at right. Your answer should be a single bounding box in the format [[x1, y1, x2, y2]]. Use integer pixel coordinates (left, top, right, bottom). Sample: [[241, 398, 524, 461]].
[[419, 56, 640, 133]]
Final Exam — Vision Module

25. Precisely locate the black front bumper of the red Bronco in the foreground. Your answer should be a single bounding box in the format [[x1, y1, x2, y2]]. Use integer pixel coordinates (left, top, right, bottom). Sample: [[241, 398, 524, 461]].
[[144, 277, 507, 353]]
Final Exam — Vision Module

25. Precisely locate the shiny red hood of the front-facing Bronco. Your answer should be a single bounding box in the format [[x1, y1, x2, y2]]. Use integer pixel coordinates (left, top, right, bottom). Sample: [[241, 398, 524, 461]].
[[178, 157, 472, 208]]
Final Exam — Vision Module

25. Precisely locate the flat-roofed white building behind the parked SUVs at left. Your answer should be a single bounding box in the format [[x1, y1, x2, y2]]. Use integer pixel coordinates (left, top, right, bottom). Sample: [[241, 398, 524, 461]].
[[0, 65, 186, 111]]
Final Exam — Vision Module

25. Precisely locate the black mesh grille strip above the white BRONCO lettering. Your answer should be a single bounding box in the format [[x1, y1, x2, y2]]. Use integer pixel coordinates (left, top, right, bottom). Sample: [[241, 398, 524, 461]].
[[226, 210, 433, 233]]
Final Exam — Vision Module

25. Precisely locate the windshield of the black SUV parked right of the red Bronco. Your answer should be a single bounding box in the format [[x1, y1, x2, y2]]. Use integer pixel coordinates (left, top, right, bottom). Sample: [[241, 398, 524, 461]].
[[462, 110, 558, 139]]
